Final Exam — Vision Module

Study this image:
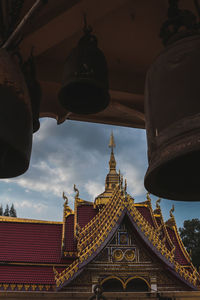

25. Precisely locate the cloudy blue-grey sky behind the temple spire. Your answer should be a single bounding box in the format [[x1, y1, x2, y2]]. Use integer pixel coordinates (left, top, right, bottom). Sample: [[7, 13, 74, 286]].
[[0, 119, 200, 227]]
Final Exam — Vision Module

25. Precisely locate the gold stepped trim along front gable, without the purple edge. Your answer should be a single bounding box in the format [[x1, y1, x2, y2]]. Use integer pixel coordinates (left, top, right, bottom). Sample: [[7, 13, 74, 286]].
[[55, 186, 199, 287]]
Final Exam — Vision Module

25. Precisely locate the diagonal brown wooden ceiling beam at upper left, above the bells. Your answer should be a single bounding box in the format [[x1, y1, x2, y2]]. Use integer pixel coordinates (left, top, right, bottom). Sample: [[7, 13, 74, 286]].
[[20, 0, 127, 59]]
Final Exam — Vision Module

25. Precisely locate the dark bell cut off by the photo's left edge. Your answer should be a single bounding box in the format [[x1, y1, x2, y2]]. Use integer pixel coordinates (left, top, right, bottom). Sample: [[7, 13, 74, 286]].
[[0, 49, 33, 178]]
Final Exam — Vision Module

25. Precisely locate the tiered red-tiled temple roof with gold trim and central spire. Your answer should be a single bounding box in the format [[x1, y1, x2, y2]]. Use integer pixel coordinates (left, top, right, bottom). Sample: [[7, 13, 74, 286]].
[[0, 137, 200, 291]]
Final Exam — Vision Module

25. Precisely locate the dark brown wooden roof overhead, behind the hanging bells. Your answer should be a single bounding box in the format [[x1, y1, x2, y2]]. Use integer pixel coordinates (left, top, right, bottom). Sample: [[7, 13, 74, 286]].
[[2, 0, 195, 128]]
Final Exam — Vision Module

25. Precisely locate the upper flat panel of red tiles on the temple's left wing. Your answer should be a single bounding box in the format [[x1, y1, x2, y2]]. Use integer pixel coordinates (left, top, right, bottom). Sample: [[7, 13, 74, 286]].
[[0, 222, 67, 263]]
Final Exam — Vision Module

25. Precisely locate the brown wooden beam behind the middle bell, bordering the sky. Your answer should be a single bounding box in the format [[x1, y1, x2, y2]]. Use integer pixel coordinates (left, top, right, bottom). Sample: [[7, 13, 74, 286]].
[[40, 81, 145, 128]]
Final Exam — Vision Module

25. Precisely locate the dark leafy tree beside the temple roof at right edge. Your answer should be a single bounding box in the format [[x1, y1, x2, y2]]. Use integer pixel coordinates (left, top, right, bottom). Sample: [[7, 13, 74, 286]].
[[179, 219, 200, 268]]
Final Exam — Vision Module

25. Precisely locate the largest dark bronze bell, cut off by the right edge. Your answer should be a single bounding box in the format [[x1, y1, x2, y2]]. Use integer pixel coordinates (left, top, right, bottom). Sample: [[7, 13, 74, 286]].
[[144, 35, 200, 201]]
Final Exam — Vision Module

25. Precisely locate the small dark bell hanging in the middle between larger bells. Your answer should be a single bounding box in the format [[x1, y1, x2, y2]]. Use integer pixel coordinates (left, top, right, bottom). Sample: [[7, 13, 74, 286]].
[[59, 30, 110, 114]]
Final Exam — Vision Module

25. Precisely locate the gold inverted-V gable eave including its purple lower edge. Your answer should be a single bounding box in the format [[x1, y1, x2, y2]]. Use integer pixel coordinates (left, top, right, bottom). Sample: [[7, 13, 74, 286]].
[[55, 186, 199, 290]]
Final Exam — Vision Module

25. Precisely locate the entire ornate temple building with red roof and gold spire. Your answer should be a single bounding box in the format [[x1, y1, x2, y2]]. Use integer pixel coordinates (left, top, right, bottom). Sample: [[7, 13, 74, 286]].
[[0, 135, 200, 299]]
